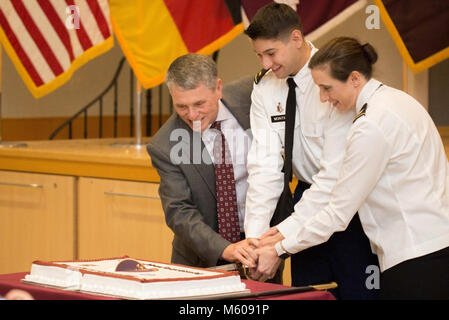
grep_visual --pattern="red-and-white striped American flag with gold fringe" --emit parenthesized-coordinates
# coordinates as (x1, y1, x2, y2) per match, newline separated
(0, 0, 113, 98)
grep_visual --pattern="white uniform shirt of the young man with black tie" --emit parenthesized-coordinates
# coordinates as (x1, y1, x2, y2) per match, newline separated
(245, 42, 354, 238)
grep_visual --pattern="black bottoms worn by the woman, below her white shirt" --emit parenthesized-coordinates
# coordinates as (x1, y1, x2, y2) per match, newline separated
(380, 247, 449, 300)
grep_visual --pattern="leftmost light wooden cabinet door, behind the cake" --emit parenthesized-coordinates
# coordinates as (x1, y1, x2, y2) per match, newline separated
(0, 171, 75, 273)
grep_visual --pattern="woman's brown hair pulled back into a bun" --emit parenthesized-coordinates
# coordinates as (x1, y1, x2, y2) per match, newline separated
(309, 37, 377, 82)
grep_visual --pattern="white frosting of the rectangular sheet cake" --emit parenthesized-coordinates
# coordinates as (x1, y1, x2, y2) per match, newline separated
(25, 259, 245, 299)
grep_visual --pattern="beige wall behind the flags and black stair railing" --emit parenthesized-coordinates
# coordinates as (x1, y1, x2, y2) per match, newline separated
(2, 0, 440, 122)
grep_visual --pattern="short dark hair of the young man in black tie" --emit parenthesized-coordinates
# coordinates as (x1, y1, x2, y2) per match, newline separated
(245, 2, 302, 40)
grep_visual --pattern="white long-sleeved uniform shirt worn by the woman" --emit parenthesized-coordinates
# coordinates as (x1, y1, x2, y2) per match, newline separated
(276, 79, 449, 276)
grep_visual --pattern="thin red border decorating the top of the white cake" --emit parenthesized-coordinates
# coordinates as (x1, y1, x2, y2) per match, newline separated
(33, 255, 240, 283)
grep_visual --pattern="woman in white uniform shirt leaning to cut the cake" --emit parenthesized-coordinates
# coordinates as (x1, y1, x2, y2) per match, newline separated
(254, 37, 449, 299)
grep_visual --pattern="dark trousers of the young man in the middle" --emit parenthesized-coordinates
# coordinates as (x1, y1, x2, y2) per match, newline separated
(291, 181, 379, 300)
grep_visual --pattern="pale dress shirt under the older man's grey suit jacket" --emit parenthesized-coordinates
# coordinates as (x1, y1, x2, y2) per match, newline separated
(201, 101, 251, 232)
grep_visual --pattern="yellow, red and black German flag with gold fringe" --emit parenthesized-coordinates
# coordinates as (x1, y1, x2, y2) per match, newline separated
(109, 0, 243, 88)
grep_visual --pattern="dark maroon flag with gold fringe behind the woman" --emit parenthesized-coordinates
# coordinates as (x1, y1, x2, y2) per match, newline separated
(374, 0, 449, 73)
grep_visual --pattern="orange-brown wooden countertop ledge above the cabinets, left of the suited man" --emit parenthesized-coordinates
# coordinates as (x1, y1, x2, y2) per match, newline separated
(0, 138, 160, 182)
